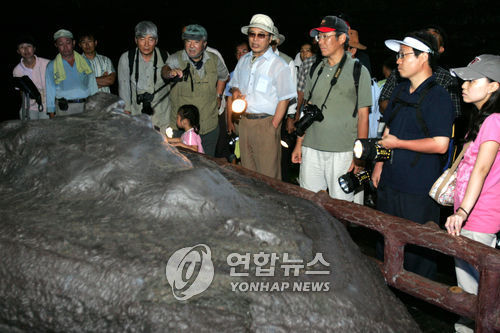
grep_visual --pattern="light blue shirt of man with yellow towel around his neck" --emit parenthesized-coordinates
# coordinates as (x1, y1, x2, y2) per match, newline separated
(45, 58, 97, 112)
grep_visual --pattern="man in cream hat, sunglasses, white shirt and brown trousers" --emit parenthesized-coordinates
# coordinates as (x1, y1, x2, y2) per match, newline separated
(229, 14, 297, 179)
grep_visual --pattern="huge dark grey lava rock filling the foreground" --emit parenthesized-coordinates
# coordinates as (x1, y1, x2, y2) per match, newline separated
(0, 94, 418, 333)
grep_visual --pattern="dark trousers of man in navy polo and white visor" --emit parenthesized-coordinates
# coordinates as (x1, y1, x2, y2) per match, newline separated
(376, 186, 439, 280)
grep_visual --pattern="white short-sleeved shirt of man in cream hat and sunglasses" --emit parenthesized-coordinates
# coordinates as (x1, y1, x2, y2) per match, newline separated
(229, 47, 297, 115)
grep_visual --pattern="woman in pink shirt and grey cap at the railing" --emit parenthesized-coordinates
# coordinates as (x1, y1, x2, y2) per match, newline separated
(446, 54, 500, 332)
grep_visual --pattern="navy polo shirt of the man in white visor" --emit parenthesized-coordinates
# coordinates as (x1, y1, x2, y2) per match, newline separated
(380, 75, 455, 194)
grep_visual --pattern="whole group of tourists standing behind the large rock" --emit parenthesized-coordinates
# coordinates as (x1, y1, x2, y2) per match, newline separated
(10, 14, 500, 331)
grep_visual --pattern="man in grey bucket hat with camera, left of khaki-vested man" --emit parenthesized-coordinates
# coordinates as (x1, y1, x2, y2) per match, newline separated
(118, 21, 170, 133)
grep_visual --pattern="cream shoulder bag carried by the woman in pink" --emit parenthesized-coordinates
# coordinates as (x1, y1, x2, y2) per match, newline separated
(429, 142, 470, 206)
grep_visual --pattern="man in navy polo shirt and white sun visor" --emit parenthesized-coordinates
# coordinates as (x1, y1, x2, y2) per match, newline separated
(372, 30, 455, 279)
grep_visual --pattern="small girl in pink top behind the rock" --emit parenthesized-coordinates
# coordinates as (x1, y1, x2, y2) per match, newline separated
(168, 104, 205, 153)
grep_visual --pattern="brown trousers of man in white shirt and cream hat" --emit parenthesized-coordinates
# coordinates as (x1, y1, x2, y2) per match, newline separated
(239, 116, 281, 179)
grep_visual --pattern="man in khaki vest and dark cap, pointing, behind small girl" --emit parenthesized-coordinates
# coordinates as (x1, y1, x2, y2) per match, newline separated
(161, 24, 229, 156)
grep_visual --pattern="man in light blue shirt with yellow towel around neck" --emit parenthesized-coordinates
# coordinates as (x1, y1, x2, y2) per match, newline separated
(45, 29, 97, 118)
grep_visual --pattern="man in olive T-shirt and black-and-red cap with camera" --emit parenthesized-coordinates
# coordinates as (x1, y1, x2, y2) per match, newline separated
(292, 16, 372, 204)
